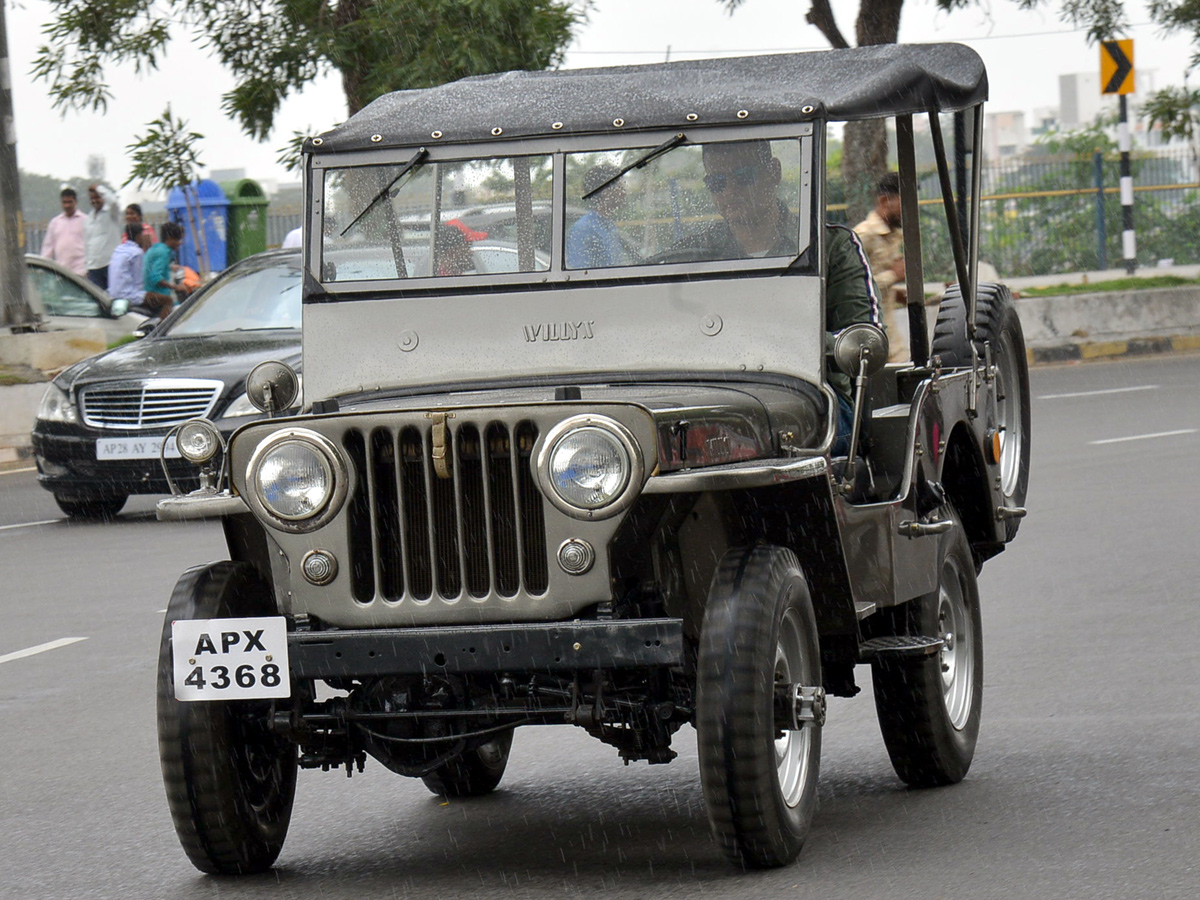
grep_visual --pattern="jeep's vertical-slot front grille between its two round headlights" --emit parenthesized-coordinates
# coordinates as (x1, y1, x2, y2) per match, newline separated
(343, 416, 550, 602)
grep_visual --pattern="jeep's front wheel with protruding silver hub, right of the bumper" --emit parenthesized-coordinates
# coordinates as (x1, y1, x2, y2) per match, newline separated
(696, 546, 821, 869)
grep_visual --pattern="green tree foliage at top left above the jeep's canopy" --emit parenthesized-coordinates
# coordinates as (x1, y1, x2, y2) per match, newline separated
(34, 0, 590, 146)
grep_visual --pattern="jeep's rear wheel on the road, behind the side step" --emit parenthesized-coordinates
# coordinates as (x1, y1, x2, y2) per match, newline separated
(871, 517, 983, 787)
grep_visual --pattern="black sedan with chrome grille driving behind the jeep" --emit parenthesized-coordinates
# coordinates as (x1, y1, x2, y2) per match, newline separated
(32, 251, 300, 517)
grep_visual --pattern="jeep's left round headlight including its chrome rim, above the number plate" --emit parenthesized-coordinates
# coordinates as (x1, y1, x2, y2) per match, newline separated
(246, 428, 349, 532)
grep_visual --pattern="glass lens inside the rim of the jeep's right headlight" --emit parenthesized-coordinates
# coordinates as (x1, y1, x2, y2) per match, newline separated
(548, 426, 630, 510)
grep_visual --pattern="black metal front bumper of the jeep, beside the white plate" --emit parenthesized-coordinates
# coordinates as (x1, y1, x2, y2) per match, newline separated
(288, 619, 683, 678)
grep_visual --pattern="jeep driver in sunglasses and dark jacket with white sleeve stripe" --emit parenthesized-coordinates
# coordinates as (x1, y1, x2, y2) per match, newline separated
(703, 140, 881, 456)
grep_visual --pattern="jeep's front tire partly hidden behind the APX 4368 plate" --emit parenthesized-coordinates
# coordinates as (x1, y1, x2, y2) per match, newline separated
(157, 562, 296, 875)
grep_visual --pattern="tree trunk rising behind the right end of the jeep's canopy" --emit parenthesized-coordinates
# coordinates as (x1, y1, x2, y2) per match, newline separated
(840, 0, 904, 226)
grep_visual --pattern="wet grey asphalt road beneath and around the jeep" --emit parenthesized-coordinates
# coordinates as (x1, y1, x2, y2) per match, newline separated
(0, 356, 1200, 900)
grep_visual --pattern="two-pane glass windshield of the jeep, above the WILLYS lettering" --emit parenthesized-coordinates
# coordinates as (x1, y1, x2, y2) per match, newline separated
(314, 128, 812, 289)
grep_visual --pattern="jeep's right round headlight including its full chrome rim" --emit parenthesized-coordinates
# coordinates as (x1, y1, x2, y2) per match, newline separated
(538, 415, 643, 518)
